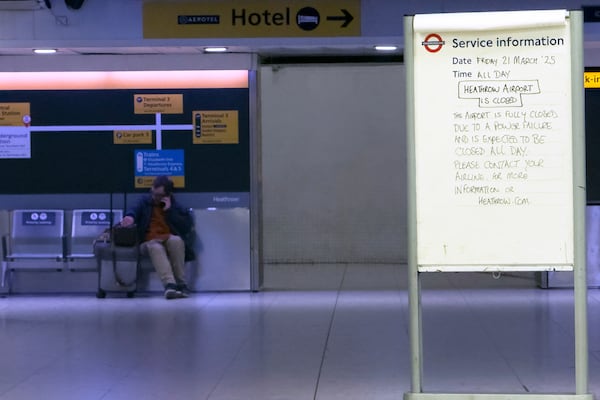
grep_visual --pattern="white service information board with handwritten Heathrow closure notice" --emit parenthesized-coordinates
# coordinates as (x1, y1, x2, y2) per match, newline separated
(409, 10, 574, 271)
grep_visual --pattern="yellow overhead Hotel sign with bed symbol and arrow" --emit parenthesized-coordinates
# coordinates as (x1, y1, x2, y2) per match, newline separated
(143, 0, 361, 39)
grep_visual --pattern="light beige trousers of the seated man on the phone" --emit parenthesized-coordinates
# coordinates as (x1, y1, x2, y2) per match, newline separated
(140, 235, 185, 285)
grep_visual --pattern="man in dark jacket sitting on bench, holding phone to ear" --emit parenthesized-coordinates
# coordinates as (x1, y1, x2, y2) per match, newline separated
(121, 176, 193, 300)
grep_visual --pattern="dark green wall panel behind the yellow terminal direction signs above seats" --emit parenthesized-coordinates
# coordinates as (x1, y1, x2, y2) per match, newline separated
(0, 89, 250, 194)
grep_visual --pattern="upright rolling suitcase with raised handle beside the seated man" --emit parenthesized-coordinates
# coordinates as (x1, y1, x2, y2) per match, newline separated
(94, 194, 140, 299)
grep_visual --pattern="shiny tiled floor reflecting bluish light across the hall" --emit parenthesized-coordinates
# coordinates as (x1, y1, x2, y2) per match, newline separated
(0, 265, 600, 400)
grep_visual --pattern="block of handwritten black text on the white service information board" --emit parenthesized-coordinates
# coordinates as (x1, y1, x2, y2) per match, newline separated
(449, 55, 567, 206)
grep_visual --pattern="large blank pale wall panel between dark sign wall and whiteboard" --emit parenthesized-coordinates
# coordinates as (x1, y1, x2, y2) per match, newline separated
(260, 64, 406, 263)
